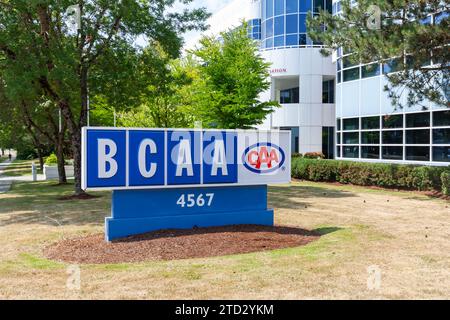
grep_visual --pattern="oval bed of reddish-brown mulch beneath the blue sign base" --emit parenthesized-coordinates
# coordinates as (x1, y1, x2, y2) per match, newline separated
(44, 225, 320, 264)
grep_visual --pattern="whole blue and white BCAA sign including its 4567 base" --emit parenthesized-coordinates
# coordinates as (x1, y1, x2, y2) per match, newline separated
(82, 128, 291, 241)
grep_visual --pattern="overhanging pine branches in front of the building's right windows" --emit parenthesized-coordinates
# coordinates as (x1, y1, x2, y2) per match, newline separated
(307, 0, 450, 107)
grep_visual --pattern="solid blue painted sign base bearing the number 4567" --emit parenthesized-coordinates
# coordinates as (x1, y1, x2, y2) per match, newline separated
(105, 185, 274, 241)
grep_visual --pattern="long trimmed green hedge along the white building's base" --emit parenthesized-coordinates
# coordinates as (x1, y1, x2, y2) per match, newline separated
(292, 158, 450, 194)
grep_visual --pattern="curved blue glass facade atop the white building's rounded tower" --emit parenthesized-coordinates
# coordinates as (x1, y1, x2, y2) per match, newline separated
(260, 0, 332, 49)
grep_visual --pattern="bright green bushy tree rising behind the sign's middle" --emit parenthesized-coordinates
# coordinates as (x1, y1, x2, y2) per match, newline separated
(191, 24, 279, 129)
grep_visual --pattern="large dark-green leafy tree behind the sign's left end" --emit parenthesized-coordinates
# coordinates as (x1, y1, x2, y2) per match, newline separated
(0, 0, 208, 195)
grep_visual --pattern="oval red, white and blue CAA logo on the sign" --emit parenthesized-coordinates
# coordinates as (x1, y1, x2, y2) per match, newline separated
(242, 142, 285, 173)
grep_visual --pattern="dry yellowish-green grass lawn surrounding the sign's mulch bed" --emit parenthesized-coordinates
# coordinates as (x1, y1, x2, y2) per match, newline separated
(0, 182, 450, 299)
